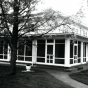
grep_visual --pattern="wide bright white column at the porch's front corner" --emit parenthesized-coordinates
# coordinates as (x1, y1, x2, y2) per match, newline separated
(65, 38, 70, 67)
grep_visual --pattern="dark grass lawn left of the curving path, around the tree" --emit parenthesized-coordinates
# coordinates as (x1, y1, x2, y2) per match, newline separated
(0, 65, 72, 88)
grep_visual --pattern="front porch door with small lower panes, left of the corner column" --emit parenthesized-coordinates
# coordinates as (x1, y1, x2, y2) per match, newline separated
(47, 45, 54, 63)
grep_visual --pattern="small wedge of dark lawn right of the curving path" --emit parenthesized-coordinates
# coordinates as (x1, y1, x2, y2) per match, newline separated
(69, 70, 88, 85)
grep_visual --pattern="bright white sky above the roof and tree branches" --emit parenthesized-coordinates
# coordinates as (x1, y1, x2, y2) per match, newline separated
(37, 0, 88, 24)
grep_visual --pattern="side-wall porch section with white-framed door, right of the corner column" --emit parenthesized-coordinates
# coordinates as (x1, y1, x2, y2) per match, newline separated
(70, 40, 81, 64)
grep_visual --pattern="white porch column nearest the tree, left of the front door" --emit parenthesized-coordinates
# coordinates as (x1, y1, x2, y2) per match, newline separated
(32, 40, 37, 64)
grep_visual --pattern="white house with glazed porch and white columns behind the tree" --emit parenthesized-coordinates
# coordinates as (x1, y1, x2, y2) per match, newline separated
(0, 17, 88, 67)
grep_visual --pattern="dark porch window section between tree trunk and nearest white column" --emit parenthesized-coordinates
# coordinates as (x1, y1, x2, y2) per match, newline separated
(18, 41, 32, 61)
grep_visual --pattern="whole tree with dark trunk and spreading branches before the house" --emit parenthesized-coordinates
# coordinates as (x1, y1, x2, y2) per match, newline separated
(0, 0, 69, 75)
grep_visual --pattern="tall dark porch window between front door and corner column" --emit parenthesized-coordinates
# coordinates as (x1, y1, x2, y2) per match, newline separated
(55, 39, 65, 64)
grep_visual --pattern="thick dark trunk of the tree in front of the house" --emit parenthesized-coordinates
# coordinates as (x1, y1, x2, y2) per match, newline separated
(10, 0, 19, 75)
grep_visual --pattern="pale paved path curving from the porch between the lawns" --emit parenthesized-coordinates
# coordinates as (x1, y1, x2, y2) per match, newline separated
(46, 70, 88, 88)
